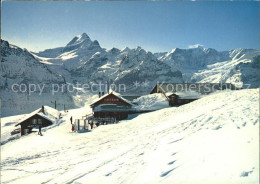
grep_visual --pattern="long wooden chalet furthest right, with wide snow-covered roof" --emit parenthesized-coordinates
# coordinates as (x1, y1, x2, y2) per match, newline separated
(150, 83, 236, 106)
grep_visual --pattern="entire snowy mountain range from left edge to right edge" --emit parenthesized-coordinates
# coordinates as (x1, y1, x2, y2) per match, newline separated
(1, 33, 260, 116)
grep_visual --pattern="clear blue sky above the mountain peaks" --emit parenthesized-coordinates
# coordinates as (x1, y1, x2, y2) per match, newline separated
(1, 1, 259, 52)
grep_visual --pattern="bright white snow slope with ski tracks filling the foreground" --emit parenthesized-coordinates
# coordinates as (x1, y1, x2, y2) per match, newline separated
(1, 89, 259, 184)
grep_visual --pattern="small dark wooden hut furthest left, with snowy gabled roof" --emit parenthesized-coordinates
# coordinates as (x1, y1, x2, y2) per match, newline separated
(15, 106, 58, 135)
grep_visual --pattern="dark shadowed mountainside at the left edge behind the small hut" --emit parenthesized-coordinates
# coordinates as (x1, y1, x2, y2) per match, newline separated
(1, 40, 75, 116)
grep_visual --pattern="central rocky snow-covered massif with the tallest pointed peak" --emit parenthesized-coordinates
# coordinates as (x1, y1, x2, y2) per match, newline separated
(34, 33, 183, 94)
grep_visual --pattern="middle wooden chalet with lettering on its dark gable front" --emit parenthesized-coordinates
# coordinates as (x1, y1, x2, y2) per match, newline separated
(90, 92, 133, 120)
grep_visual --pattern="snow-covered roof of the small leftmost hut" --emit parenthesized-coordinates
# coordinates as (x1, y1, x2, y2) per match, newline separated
(15, 106, 60, 126)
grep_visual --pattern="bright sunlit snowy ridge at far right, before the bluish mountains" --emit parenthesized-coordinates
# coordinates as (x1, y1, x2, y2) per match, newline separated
(191, 49, 260, 88)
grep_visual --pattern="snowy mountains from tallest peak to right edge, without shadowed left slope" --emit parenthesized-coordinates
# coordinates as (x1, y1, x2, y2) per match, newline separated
(35, 33, 260, 89)
